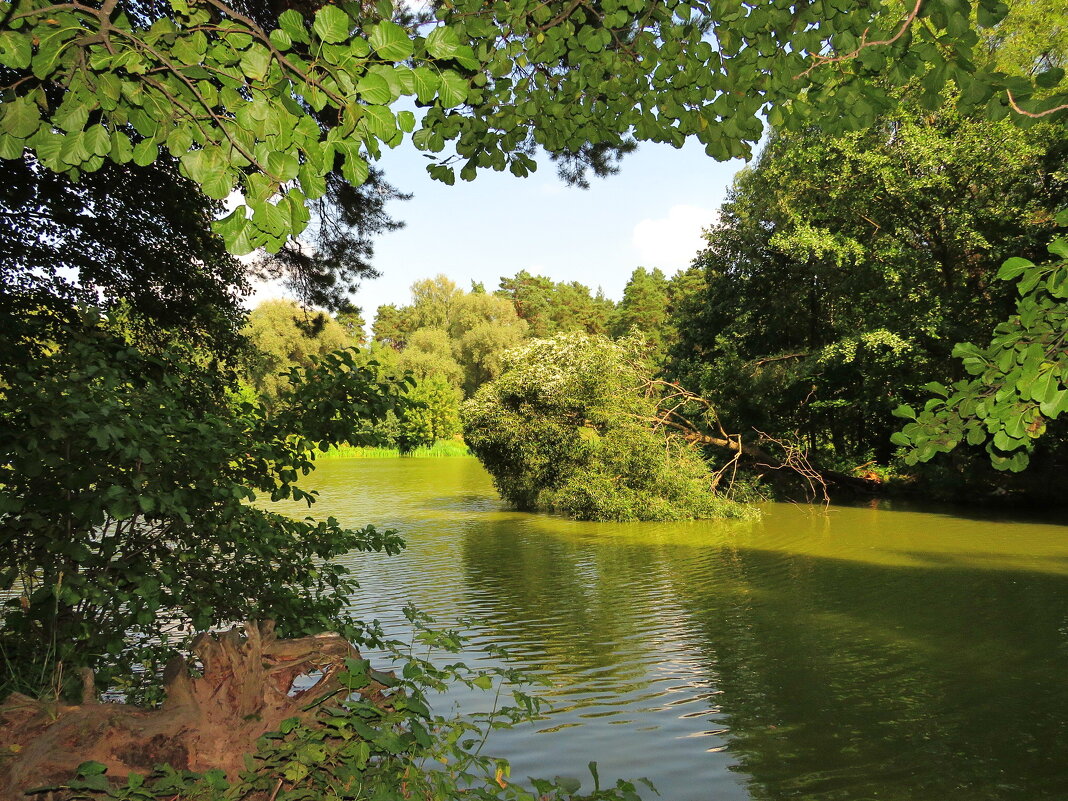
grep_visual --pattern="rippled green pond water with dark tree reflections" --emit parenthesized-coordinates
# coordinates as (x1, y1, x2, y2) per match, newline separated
(299, 458, 1068, 801)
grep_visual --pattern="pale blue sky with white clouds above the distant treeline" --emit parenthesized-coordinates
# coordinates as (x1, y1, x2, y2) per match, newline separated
(253, 135, 743, 324)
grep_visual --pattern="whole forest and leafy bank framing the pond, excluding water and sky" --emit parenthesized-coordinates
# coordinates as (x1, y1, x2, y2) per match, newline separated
(0, 0, 1068, 801)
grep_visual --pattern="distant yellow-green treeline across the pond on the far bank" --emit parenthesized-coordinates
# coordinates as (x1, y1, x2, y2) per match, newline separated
(244, 267, 690, 452)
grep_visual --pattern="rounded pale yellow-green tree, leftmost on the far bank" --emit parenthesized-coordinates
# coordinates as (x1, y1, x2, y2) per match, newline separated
(242, 300, 356, 401)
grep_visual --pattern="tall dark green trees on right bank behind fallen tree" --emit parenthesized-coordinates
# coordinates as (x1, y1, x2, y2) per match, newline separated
(670, 95, 1068, 468)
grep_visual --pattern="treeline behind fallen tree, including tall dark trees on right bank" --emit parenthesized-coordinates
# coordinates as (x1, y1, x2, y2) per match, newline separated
(326, 92, 1068, 497)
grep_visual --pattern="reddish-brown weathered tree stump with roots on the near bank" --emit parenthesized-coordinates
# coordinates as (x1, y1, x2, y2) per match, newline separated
(0, 622, 389, 801)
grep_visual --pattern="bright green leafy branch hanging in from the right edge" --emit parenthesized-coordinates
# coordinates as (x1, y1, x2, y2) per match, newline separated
(893, 226, 1068, 472)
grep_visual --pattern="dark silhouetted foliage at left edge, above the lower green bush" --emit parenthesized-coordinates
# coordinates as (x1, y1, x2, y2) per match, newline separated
(0, 158, 248, 361)
